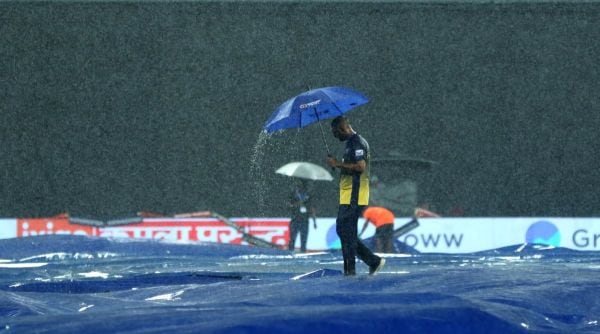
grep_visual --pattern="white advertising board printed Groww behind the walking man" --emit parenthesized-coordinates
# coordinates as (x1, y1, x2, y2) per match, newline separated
(296, 217, 600, 253)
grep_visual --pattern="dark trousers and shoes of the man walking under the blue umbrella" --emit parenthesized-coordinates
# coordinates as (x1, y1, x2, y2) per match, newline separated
(336, 205, 379, 275)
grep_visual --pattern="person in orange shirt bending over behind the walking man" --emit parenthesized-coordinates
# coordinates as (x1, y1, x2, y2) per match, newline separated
(359, 206, 394, 253)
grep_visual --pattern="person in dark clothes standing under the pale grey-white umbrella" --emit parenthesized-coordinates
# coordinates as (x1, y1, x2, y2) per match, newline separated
(288, 180, 317, 253)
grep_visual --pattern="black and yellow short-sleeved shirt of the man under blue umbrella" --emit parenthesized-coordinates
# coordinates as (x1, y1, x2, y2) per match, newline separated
(340, 133, 371, 205)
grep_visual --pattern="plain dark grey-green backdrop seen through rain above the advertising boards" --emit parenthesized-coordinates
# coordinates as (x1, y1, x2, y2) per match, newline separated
(0, 2, 600, 217)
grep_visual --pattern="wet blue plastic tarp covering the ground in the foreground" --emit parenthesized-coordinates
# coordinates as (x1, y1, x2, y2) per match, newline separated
(0, 236, 600, 334)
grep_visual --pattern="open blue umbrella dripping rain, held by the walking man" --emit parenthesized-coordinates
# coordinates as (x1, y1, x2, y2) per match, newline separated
(263, 87, 369, 153)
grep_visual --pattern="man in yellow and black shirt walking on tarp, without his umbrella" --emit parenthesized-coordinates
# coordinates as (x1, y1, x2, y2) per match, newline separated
(327, 116, 385, 276)
